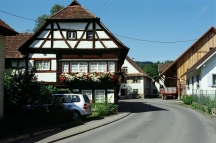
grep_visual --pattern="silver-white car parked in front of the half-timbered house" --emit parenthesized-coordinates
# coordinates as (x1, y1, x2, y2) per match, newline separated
(52, 93, 92, 119)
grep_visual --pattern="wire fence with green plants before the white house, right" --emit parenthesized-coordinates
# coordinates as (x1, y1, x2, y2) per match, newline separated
(192, 89, 216, 108)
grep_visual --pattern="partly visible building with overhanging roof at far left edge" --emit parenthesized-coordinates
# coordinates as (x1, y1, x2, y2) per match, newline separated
(0, 19, 17, 119)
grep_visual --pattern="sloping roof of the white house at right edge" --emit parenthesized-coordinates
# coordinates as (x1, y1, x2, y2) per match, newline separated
(181, 48, 216, 77)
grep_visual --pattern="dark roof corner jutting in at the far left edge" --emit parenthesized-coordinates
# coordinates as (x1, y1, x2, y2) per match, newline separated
(0, 19, 18, 36)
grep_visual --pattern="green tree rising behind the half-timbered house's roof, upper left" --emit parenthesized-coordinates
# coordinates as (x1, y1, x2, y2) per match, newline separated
(33, 4, 64, 32)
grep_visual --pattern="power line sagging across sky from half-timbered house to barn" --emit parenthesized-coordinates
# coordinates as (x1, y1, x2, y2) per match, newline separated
(113, 33, 197, 44)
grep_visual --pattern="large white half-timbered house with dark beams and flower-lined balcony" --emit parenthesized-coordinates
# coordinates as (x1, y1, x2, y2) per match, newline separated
(19, 0, 129, 102)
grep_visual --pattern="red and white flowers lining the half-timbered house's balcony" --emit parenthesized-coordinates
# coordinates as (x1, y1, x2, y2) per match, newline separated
(60, 72, 118, 82)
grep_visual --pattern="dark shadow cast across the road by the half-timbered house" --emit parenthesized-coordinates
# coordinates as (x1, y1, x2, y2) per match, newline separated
(119, 101, 168, 113)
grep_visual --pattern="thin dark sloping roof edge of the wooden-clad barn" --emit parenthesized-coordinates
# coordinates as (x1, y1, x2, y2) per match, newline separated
(157, 26, 216, 80)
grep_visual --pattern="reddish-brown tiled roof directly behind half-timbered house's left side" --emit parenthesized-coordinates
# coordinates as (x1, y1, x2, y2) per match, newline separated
(5, 33, 33, 58)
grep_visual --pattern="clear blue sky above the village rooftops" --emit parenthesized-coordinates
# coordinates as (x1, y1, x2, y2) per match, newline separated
(0, 0, 216, 62)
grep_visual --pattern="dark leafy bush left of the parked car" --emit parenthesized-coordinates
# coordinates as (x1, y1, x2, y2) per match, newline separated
(4, 69, 51, 109)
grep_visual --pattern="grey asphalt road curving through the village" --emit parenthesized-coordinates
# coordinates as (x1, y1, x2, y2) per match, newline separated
(55, 99, 216, 143)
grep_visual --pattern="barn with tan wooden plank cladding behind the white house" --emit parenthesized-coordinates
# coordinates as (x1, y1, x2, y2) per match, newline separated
(157, 27, 216, 99)
